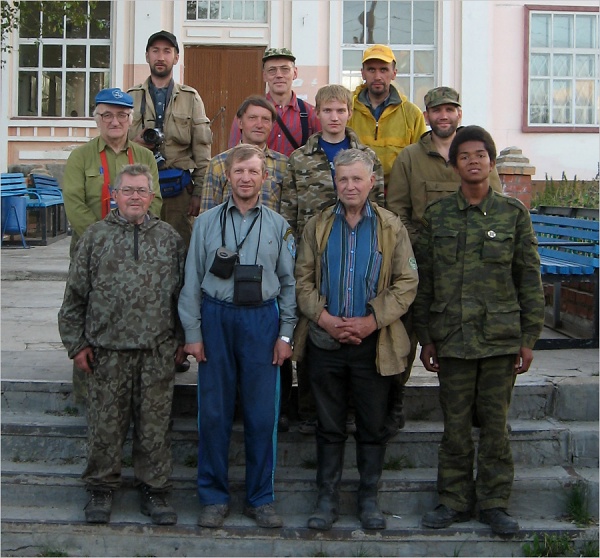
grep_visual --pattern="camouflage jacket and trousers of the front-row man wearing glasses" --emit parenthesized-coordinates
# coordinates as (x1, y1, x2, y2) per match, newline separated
(58, 210, 185, 491)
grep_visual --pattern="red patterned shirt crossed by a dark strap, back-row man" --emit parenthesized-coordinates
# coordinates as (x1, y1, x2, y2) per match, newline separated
(229, 91, 321, 157)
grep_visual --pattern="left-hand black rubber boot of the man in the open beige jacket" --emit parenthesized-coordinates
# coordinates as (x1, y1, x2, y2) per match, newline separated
(308, 443, 344, 531)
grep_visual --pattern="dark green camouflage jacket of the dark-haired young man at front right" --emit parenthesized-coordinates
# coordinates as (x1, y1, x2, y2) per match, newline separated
(413, 189, 544, 359)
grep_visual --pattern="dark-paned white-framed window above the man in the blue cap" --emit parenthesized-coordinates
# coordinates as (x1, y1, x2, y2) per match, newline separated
(18, 1, 111, 117)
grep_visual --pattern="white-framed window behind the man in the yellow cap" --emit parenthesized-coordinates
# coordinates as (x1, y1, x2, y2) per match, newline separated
(342, 0, 437, 106)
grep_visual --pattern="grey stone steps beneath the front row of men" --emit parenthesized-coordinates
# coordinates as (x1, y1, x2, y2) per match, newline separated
(1, 360, 599, 556)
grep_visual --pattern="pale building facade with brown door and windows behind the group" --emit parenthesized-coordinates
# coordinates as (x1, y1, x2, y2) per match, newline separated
(0, 0, 600, 179)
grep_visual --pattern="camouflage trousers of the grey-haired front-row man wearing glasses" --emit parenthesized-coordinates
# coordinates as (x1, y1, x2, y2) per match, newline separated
(82, 340, 176, 492)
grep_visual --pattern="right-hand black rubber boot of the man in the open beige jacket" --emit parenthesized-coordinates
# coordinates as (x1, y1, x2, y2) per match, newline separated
(356, 444, 386, 529)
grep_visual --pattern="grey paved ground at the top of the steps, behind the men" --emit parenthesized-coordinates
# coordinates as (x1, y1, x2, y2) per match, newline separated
(0, 238, 599, 383)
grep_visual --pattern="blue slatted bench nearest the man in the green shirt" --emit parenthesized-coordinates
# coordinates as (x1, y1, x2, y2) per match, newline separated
(27, 174, 67, 246)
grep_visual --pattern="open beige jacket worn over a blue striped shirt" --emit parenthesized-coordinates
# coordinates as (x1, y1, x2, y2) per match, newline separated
(293, 202, 419, 376)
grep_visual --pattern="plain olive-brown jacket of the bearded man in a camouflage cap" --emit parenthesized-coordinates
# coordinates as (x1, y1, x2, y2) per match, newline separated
(385, 128, 502, 245)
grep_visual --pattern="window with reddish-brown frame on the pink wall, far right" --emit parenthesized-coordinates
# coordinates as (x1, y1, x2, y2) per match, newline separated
(525, 7, 600, 131)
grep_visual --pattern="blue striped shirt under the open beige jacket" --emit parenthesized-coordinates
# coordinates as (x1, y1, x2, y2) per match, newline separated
(321, 201, 382, 318)
